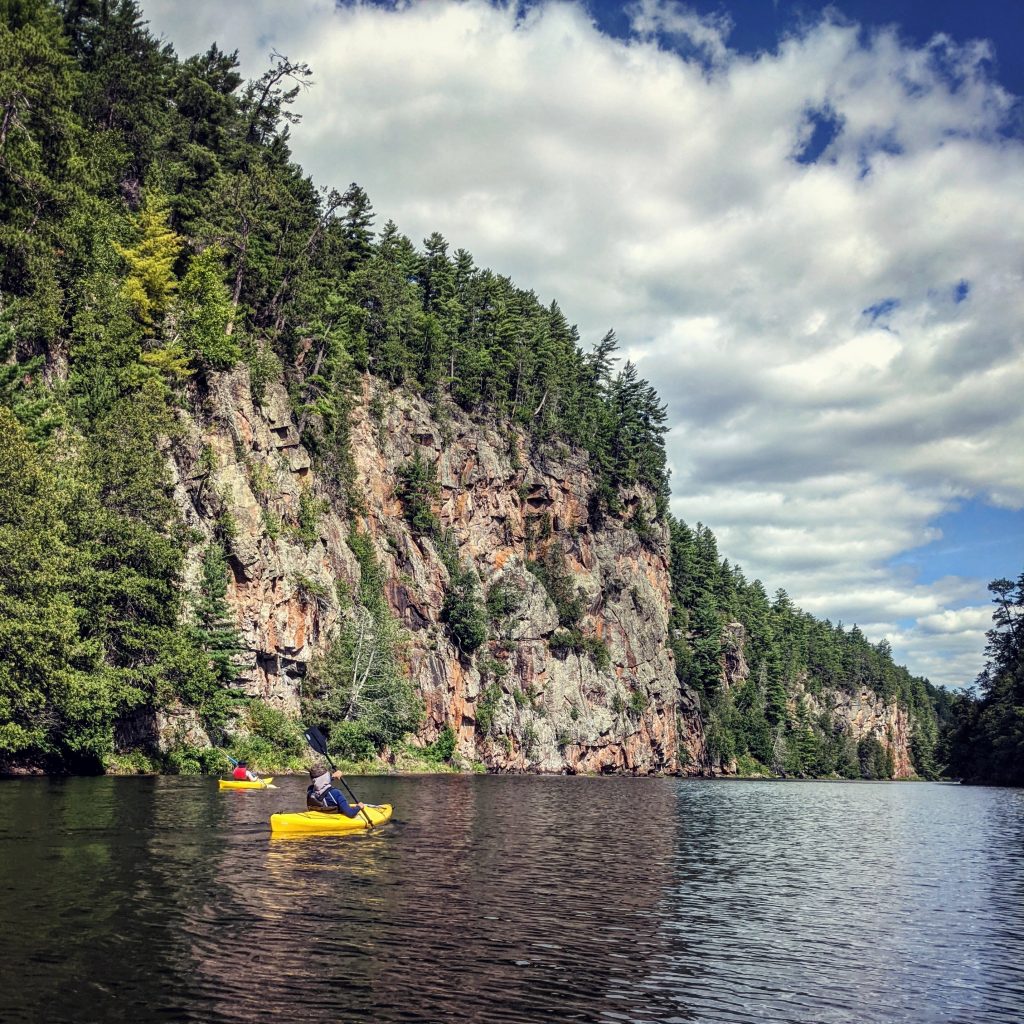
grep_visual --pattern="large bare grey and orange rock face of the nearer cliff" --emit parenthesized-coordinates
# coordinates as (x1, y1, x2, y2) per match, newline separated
(165, 367, 707, 773)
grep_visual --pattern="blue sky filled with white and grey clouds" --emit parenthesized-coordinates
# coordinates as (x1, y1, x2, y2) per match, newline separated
(142, 0, 1024, 686)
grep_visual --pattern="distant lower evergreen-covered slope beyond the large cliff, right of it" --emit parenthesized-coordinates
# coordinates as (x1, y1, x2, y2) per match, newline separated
(672, 521, 939, 778)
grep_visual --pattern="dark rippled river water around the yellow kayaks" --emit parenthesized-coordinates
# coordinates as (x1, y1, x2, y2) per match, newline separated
(0, 776, 1024, 1024)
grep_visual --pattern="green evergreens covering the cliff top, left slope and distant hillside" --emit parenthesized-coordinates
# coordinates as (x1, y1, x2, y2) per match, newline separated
(0, 0, 987, 777)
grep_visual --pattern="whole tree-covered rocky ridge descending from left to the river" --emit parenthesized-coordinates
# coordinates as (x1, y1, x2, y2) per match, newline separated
(0, 0, 937, 777)
